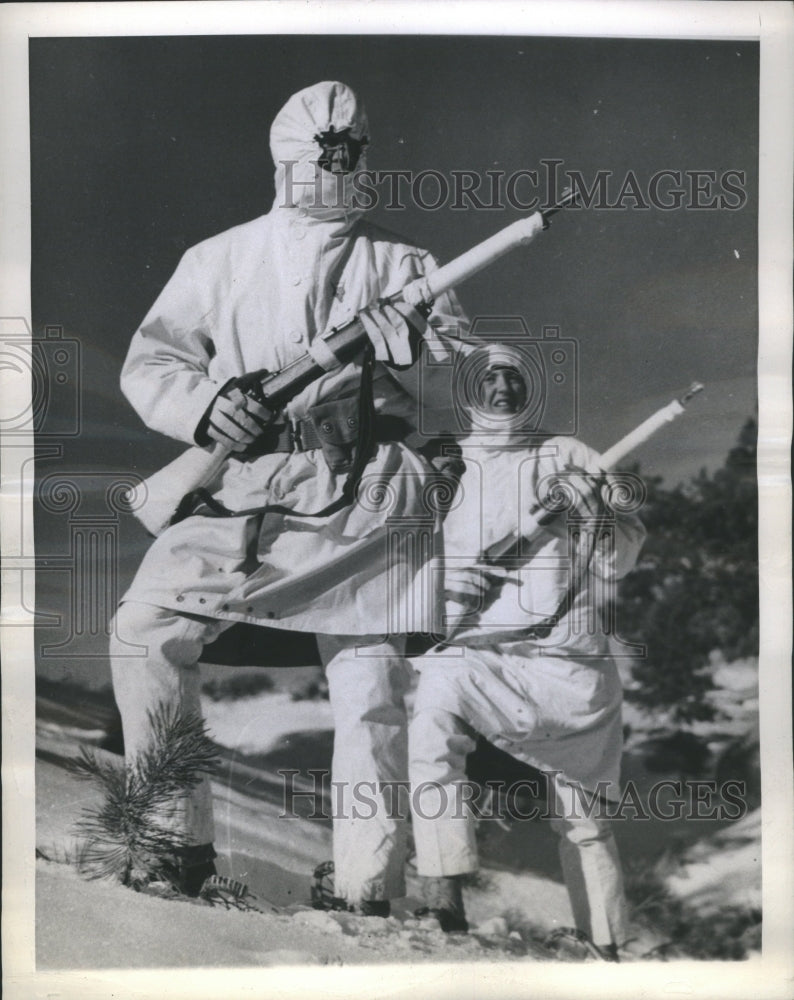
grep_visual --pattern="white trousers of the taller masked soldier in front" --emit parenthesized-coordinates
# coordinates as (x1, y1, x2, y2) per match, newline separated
(110, 601, 409, 903)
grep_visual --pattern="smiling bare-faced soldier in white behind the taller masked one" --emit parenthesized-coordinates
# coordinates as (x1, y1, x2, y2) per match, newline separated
(409, 345, 645, 958)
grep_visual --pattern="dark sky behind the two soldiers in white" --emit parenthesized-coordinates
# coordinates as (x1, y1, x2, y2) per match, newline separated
(30, 35, 758, 616)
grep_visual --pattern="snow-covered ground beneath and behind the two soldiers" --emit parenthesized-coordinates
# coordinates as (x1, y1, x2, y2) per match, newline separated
(36, 663, 760, 969)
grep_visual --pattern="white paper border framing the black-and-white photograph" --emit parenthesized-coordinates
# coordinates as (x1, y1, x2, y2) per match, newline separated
(0, 0, 794, 1000)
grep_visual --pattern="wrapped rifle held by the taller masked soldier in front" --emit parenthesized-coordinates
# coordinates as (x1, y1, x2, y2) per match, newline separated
(129, 190, 576, 535)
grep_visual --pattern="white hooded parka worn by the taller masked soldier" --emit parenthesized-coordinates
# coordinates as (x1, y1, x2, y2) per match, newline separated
(121, 83, 465, 635)
